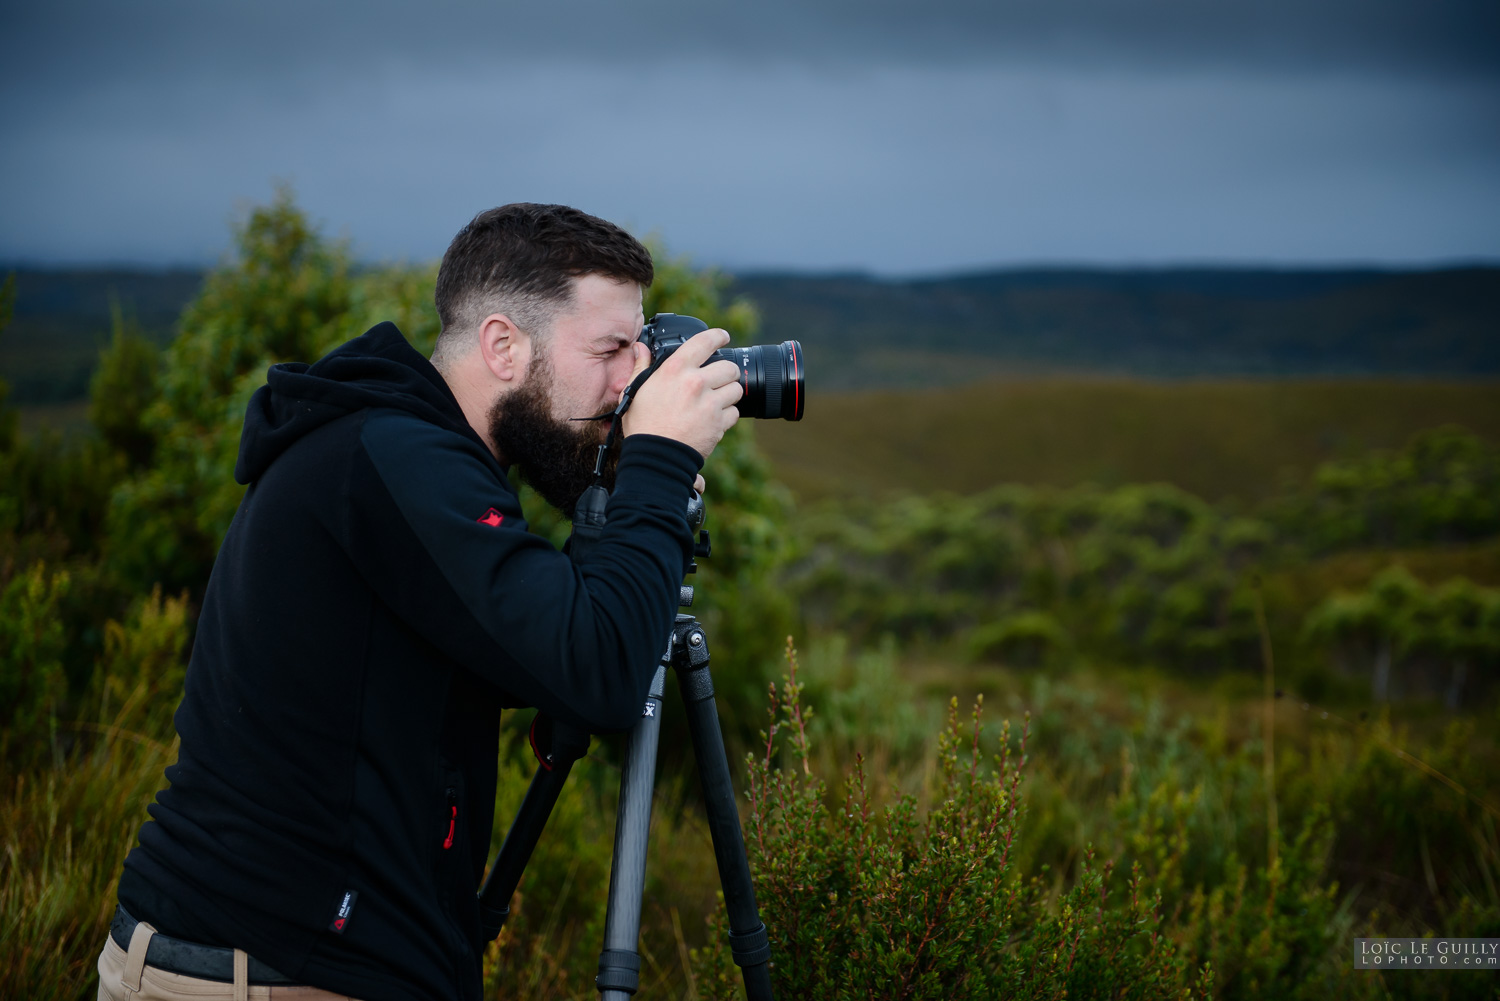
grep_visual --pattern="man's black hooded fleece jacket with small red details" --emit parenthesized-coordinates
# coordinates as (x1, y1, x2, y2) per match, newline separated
(120, 323, 702, 1001)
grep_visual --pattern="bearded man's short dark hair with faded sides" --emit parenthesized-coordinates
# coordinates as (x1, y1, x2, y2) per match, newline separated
(432, 201, 656, 360)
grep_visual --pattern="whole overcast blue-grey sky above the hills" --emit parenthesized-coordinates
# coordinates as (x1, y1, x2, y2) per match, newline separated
(0, 0, 1500, 275)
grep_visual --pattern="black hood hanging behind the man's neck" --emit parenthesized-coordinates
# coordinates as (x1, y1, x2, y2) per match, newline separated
(234, 323, 489, 485)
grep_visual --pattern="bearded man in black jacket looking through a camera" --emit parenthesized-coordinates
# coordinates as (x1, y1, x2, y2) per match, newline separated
(99, 204, 741, 1001)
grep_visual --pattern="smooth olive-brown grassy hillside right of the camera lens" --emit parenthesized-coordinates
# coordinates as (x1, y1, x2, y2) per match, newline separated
(756, 374, 1500, 504)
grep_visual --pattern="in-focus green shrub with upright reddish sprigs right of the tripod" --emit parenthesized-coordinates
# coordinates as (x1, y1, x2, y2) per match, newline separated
(698, 644, 1212, 998)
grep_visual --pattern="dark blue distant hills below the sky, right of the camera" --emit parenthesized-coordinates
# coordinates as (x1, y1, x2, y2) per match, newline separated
(732, 267, 1500, 389)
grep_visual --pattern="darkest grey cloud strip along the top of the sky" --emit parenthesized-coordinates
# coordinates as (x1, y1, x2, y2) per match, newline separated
(0, 0, 1500, 87)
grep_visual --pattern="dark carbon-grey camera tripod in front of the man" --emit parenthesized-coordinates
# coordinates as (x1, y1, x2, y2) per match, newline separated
(479, 486, 771, 1001)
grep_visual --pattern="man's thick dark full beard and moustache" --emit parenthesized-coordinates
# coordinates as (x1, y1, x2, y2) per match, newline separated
(489, 354, 620, 521)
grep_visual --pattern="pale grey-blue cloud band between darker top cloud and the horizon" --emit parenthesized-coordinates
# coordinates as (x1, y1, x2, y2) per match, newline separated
(0, 60, 1500, 273)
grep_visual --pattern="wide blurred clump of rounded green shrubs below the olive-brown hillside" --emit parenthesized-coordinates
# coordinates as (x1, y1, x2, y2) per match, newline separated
(788, 485, 1274, 669)
